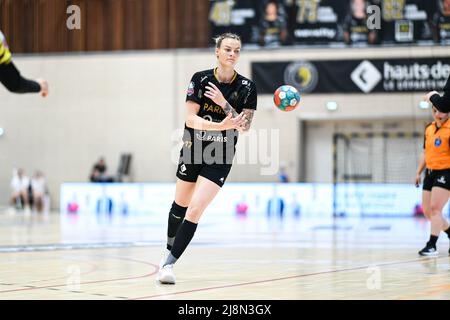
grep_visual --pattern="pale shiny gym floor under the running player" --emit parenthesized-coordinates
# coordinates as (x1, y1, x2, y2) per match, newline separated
(0, 211, 450, 300)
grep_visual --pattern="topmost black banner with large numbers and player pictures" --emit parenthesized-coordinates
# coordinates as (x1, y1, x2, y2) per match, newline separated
(209, 0, 442, 45)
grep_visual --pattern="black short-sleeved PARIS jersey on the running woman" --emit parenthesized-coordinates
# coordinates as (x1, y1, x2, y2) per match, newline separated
(183, 69, 257, 164)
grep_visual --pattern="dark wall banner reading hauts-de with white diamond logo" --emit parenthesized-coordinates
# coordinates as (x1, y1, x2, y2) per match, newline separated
(252, 57, 450, 94)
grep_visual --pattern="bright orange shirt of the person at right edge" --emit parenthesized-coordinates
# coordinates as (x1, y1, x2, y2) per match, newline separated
(424, 120, 450, 170)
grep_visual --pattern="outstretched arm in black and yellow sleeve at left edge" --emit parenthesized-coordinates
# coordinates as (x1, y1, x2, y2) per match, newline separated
(0, 31, 48, 97)
